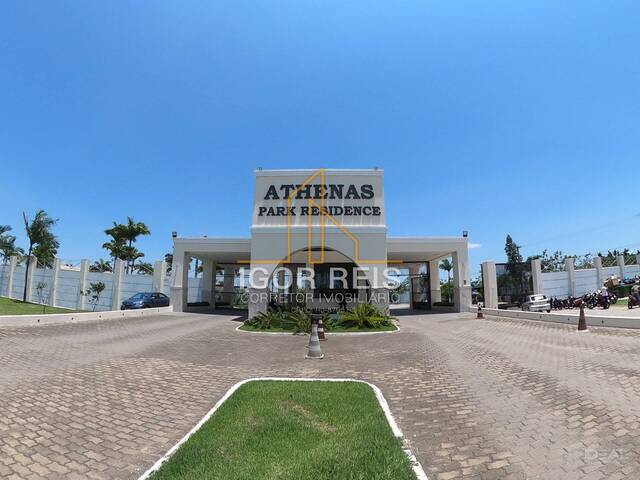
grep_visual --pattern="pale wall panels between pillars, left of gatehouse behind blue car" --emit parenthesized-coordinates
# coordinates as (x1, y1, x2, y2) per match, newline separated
(0, 265, 202, 311)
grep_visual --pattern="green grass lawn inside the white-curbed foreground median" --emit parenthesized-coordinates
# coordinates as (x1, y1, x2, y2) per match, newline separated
(151, 380, 416, 480)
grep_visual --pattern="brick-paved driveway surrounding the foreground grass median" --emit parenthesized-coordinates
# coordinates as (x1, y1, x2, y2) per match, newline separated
(0, 314, 640, 480)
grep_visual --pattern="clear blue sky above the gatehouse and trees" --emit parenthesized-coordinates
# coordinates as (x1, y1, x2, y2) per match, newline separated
(0, 0, 640, 272)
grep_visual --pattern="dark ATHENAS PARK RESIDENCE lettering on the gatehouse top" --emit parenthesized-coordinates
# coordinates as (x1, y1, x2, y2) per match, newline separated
(258, 183, 381, 217)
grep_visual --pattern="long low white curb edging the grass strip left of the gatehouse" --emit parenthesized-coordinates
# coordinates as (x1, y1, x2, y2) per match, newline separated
(0, 307, 172, 328)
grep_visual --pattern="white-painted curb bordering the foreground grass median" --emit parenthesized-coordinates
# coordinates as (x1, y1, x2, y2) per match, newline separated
(138, 377, 429, 480)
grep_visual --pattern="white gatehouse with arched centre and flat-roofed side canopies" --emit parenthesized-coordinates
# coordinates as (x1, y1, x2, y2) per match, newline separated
(171, 169, 471, 317)
